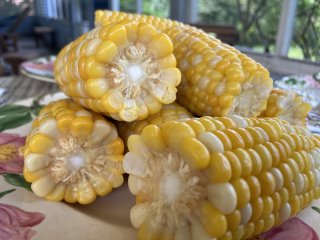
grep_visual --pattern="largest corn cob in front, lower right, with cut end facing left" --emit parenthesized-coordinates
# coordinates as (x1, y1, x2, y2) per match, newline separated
(123, 116, 320, 240)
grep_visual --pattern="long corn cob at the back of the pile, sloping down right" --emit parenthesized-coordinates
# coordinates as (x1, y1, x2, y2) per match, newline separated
(95, 11, 272, 117)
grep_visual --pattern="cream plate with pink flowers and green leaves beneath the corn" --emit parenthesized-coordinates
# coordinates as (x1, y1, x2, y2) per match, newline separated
(0, 93, 320, 240)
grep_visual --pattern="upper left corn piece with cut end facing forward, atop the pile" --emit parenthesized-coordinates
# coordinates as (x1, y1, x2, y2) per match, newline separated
(55, 21, 181, 121)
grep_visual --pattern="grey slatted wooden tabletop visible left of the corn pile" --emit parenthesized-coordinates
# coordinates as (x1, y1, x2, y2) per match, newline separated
(0, 75, 59, 105)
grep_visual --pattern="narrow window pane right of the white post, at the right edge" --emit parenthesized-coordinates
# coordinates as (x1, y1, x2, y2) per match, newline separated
(288, 0, 320, 62)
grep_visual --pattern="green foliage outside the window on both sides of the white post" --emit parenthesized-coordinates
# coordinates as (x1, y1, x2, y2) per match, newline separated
(198, 0, 320, 61)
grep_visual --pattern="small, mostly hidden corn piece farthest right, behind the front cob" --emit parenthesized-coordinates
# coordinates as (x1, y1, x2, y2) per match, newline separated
(260, 88, 311, 126)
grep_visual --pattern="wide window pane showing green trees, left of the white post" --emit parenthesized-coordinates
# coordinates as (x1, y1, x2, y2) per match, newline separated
(198, 0, 282, 53)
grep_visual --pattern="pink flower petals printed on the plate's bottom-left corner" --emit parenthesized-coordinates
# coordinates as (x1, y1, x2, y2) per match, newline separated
(0, 203, 45, 240)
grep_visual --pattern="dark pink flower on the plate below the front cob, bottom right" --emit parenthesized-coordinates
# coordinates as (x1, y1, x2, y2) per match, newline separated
(254, 217, 319, 240)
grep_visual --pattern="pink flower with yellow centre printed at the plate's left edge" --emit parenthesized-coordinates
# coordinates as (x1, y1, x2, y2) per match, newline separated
(0, 132, 26, 173)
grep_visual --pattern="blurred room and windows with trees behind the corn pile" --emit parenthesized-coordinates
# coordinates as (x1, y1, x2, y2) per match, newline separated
(0, 0, 320, 77)
